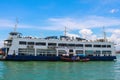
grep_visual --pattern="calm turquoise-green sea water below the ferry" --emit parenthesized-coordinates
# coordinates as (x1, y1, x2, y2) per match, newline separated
(0, 54, 120, 80)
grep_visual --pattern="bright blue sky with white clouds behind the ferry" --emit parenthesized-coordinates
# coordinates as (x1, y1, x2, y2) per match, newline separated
(0, 0, 120, 50)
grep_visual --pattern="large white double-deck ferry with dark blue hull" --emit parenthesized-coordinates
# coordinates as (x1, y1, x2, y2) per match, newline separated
(1, 26, 116, 61)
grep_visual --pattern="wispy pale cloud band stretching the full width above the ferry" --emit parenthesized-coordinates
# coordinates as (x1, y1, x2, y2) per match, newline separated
(0, 16, 120, 31)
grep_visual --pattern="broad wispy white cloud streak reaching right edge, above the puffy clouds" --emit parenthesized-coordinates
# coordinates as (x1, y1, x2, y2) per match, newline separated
(48, 16, 120, 30)
